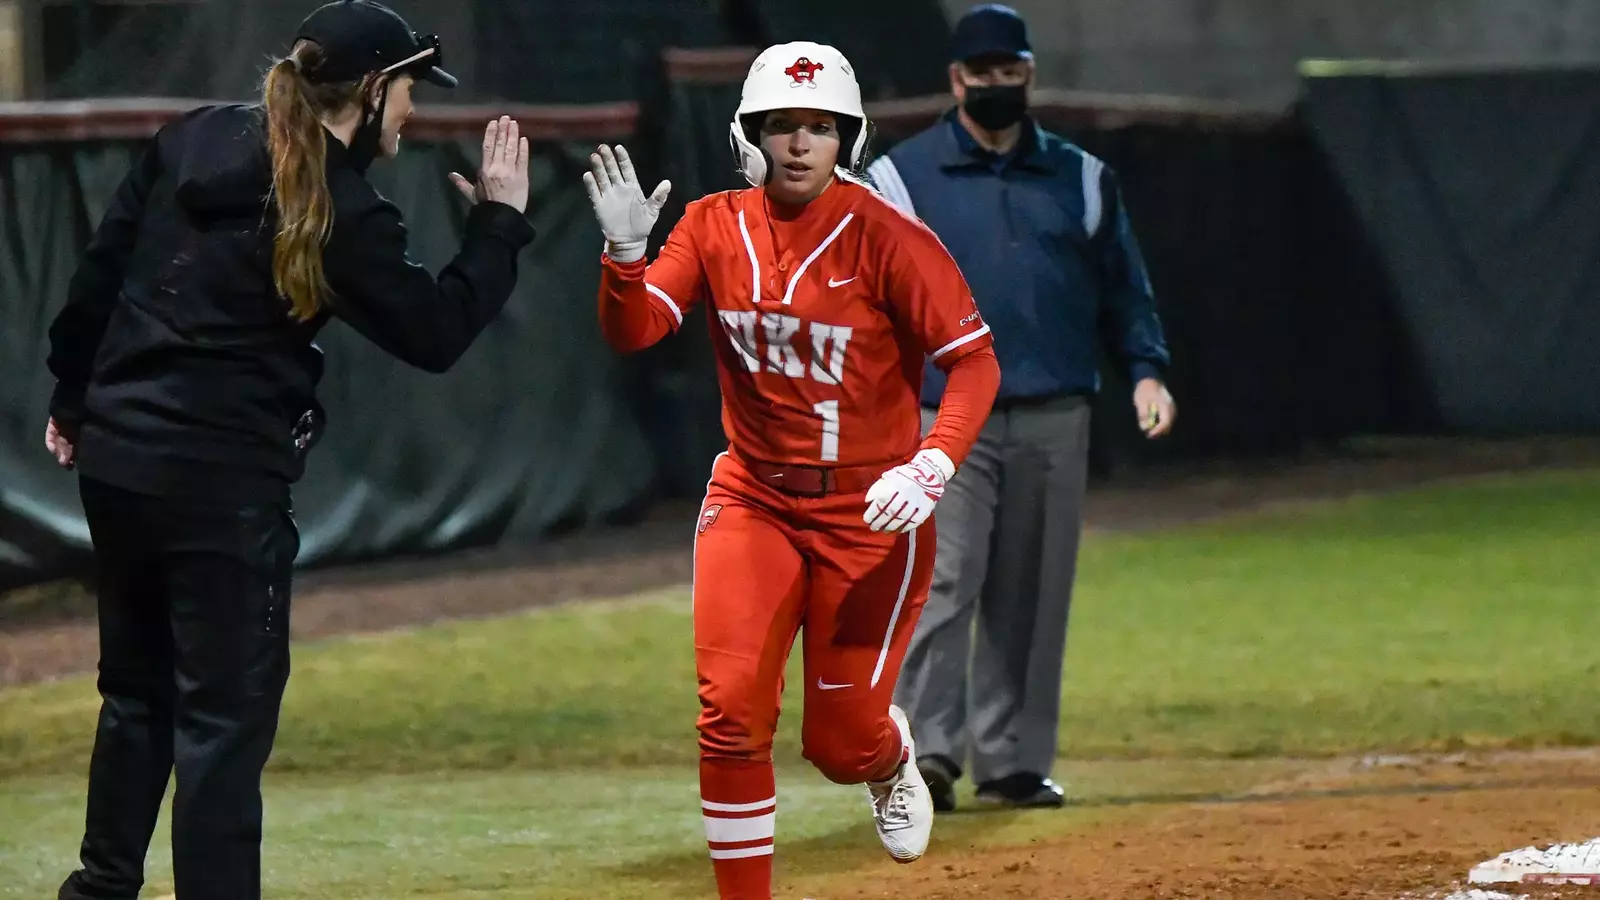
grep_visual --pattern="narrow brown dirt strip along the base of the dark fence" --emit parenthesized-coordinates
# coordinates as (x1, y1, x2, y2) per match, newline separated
(0, 439, 1600, 687)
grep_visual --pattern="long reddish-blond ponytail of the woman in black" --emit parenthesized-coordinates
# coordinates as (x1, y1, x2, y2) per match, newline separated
(261, 40, 362, 322)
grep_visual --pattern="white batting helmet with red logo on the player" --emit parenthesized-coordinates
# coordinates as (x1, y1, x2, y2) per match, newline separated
(728, 40, 867, 187)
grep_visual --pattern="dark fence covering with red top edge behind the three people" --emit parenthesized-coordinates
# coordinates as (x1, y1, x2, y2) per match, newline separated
(0, 31, 1600, 588)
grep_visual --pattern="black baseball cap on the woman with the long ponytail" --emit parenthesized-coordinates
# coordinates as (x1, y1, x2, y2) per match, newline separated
(294, 0, 459, 88)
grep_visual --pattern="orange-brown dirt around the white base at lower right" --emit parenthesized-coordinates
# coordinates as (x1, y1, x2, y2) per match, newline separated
(832, 751, 1600, 900)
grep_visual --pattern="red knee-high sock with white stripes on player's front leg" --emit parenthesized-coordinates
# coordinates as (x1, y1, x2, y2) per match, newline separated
(701, 756, 778, 900)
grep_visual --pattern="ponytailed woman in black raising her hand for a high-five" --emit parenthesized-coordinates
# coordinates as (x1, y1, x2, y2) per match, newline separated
(37, 0, 533, 900)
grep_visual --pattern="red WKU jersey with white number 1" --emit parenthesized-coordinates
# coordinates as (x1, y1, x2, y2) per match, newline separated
(600, 179, 998, 466)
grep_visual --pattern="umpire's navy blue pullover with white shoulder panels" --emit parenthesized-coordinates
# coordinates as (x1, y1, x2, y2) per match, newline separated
(867, 109, 1170, 407)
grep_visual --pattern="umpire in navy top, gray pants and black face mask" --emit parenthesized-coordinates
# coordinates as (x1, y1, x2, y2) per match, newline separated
(867, 5, 1174, 810)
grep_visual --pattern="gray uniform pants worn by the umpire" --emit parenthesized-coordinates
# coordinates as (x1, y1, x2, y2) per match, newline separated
(894, 397, 1090, 783)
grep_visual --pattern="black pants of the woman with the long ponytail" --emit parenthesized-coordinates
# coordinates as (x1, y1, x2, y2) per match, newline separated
(61, 477, 299, 900)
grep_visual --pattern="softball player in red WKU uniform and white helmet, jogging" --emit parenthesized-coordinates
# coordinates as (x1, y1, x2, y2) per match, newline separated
(584, 42, 1000, 900)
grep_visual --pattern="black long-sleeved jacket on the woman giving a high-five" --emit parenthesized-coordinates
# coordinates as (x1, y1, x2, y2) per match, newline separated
(48, 106, 533, 500)
